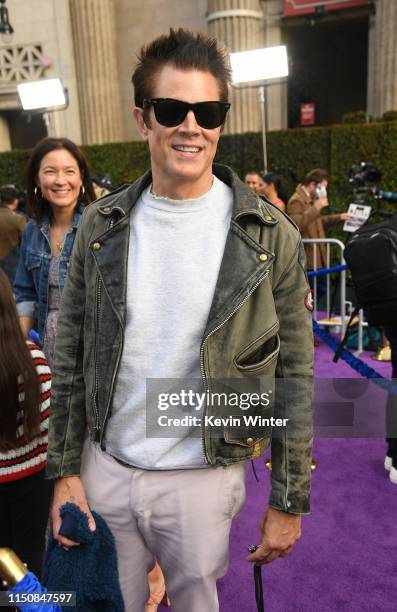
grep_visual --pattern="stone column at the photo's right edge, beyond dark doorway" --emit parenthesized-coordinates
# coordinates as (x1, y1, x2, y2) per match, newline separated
(367, 0, 397, 116)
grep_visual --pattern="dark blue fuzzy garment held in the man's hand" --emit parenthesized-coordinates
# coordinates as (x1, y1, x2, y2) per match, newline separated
(43, 503, 123, 612)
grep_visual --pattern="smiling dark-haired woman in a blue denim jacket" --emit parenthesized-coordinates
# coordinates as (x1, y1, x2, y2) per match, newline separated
(14, 138, 95, 364)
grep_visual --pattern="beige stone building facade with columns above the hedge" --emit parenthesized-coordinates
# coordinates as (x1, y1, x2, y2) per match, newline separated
(0, 0, 397, 151)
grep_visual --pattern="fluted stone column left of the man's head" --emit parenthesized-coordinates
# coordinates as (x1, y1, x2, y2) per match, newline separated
(70, 0, 122, 144)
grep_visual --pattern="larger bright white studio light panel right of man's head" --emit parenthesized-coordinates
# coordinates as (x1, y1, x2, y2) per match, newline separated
(230, 45, 288, 85)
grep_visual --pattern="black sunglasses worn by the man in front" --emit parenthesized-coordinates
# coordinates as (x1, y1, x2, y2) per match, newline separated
(143, 98, 230, 130)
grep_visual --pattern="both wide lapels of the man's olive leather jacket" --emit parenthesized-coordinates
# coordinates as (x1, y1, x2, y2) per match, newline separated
(90, 164, 277, 335)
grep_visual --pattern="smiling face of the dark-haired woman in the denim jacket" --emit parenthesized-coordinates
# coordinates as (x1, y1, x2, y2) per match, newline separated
(37, 149, 83, 210)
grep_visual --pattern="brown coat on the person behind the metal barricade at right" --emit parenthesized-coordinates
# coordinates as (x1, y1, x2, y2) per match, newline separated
(286, 185, 340, 270)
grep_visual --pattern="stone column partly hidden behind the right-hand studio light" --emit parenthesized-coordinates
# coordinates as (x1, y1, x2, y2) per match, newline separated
(207, 0, 264, 134)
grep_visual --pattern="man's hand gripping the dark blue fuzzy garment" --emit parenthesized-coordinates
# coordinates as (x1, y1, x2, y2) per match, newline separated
(51, 476, 96, 547)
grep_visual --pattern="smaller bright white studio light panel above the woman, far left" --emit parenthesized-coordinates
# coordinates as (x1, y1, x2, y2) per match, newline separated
(18, 79, 66, 110)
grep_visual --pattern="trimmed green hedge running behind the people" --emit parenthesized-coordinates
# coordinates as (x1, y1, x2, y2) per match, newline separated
(0, 122, 397, 219)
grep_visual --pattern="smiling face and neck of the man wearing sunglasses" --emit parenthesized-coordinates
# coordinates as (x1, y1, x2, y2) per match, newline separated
(134, 65, 221, 199)
